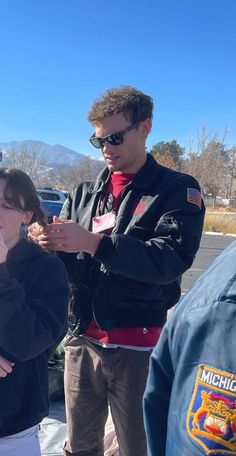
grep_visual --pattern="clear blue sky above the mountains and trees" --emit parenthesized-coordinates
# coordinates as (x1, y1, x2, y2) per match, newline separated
(0, 0, 236, 156)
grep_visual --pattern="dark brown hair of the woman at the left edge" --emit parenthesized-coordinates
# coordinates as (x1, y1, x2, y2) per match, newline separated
(0, 168, 46, 225)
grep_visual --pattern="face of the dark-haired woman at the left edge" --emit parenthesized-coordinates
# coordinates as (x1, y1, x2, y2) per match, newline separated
(0, 178, 32, 249)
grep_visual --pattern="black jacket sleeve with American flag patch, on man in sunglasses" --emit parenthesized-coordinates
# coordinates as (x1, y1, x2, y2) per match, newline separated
(95, 176, 205, 285)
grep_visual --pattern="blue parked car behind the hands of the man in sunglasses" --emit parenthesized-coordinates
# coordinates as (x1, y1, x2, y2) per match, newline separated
(36, 187, 66, 223)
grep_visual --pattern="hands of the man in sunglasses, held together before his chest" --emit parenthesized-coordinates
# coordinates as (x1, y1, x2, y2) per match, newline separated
(29, 217, 101, 255)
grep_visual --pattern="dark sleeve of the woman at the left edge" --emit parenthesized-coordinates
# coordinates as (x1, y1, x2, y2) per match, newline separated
(0, 255, 68, 361)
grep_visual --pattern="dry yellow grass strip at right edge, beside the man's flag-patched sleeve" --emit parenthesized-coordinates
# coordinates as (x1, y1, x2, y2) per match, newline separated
(203, 212, 236, 234)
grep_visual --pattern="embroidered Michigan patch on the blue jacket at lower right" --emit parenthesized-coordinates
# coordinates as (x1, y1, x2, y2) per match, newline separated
(186, 365, 236, 455)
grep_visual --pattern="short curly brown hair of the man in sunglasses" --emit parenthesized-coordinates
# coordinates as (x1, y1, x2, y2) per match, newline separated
(88, 86, 153, 125)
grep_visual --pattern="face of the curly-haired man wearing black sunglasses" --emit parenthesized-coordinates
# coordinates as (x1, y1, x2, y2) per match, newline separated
(94, 114, 151, 174)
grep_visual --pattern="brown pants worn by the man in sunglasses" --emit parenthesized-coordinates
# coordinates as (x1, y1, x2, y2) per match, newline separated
(64, 336, 151, 456)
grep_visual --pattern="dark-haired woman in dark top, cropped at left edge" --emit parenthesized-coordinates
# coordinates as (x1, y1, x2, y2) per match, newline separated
(0, 168, 68, 456)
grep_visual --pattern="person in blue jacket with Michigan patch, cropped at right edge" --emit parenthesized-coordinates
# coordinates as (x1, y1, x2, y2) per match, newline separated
(143, 241, 236, 456)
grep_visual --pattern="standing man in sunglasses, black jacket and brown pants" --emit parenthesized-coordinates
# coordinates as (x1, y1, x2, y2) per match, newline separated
(31, 86, 204, 456)
